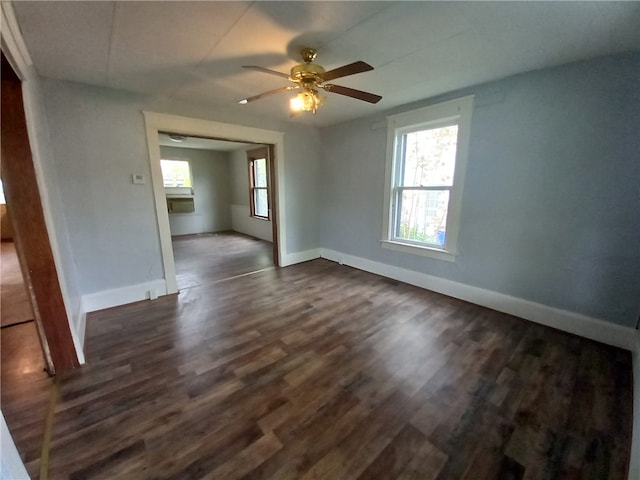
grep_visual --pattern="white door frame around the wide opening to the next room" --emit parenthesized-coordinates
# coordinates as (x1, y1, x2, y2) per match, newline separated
(142, 111, 287, 294)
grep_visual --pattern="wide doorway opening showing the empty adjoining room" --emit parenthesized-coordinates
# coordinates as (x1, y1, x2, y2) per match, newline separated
(158, 132, 277, 290)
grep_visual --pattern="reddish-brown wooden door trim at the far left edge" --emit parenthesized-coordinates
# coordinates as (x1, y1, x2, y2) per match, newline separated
(0, 53, 79, 374)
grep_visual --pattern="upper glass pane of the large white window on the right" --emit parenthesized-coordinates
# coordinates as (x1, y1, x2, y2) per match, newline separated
(402, 125, 458, 187)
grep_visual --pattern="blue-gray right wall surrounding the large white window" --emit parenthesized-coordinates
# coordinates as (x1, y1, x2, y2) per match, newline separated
(319, 55, 640, 326)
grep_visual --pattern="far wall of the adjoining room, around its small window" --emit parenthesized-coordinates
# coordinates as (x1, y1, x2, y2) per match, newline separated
(160, 146, 231, 235)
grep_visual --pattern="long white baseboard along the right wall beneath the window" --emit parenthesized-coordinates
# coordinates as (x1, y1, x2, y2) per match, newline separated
(321, 249, 636, 351)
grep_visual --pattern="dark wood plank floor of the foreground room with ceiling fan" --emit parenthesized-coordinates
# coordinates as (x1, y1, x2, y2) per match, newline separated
(3, 232, 632, 480)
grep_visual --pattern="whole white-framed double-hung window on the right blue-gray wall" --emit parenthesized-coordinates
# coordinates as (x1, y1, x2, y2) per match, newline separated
(383, 96, 473, 261)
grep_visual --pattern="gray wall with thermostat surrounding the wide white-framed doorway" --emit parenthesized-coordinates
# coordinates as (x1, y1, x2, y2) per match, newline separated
(42, 79, 320, 295)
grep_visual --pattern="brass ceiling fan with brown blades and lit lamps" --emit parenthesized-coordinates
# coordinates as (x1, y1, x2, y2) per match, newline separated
(238, 48, 382, 115)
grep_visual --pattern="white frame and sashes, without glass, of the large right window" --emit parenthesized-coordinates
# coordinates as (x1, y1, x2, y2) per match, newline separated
(381, 95, 473, 262)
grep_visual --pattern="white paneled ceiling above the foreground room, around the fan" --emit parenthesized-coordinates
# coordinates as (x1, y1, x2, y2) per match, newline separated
(14, 1, 640, 126)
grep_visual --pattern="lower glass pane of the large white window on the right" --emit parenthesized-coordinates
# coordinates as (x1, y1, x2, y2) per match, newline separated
(396, 190, 449, 247)
